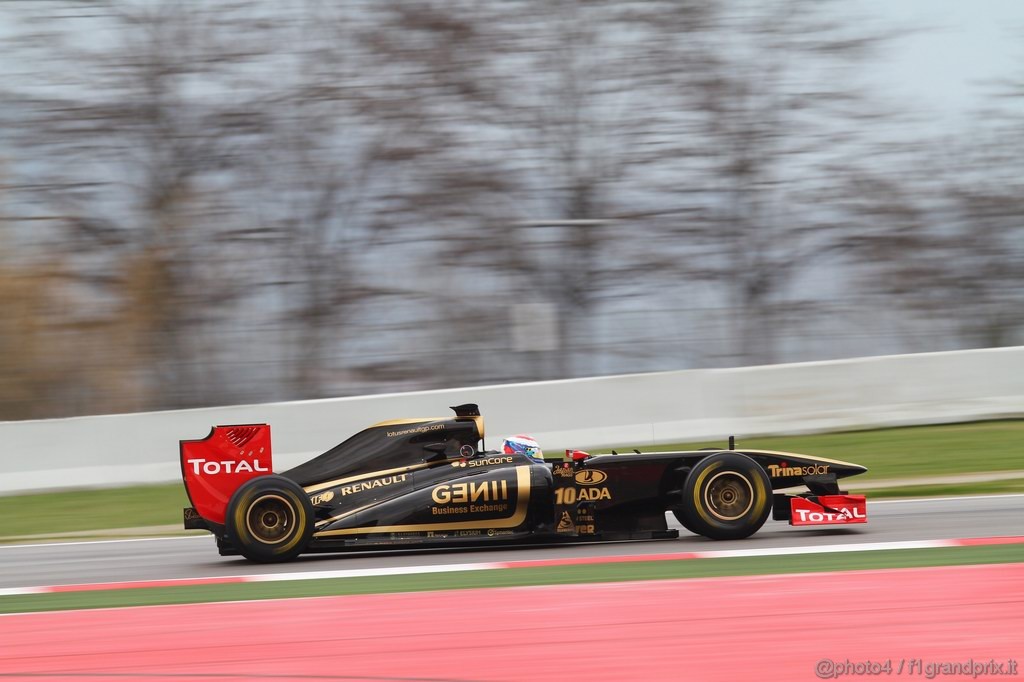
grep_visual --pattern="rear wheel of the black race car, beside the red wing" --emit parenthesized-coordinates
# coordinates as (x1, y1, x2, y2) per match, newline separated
(225, 475, 313, 563)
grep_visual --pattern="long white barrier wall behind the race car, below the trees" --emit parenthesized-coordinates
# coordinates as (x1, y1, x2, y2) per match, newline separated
(0, 346, 1024, 495)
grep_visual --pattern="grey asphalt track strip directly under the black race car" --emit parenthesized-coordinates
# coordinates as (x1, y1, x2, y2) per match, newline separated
(0, 495, 1024, 589)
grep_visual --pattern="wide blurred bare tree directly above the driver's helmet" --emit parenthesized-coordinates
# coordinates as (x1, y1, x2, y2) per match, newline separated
(364, 0, 709, 378)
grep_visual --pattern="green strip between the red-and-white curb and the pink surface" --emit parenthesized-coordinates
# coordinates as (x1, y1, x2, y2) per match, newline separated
(0, 545, 1024, 613)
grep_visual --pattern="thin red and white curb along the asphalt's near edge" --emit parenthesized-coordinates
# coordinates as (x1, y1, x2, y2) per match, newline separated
(0, 536, 1024, 597)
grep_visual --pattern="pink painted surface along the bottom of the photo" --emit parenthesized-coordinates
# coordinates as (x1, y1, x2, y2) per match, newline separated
(0, 564, 1024, 682)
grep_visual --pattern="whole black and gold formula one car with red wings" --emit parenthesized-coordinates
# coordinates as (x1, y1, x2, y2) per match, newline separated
(180, 404, 867, 561)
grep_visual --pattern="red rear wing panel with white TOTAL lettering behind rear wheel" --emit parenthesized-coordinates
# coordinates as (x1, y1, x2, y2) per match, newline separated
(180, 424, 273, 524)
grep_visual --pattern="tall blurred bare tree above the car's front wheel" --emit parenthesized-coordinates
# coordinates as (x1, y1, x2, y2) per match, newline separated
(649, 0, 887, 365)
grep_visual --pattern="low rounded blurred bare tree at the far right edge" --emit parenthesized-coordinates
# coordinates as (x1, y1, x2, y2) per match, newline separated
(846, 122, 1024, 347)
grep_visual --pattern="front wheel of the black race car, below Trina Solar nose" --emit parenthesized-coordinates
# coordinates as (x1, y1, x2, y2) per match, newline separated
(672, 453, 771, 540)
